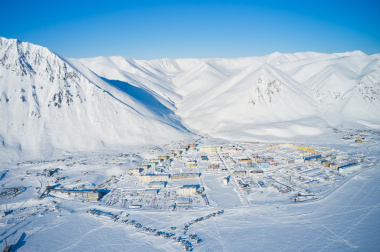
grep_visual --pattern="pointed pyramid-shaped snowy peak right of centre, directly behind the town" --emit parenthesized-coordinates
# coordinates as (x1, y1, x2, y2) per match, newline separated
(174, 64, 325, 140)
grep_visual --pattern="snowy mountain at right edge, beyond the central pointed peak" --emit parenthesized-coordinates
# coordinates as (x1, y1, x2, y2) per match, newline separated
(278, 51, 380, 126)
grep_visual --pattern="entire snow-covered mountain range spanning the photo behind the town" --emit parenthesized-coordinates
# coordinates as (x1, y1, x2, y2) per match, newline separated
(0, 38, 380, 157)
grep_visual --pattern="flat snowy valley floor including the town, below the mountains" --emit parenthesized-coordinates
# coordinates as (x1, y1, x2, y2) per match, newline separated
(0, 132, 380, 251)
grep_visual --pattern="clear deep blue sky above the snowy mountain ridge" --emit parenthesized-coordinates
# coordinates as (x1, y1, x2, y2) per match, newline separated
(0, 0, 380, 59)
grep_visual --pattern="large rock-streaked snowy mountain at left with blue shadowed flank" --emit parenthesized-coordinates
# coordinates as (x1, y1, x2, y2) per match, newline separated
(0, 38, 188, 158)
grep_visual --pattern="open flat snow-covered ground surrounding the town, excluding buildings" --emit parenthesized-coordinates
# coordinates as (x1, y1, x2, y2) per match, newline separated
(0, 133, 380, 251)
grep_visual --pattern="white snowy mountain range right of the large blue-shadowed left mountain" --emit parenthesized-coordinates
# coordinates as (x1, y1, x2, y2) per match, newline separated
(80, 51, 380, 140)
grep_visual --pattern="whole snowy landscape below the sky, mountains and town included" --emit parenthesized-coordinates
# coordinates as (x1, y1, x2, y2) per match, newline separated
(0, 37, 380, 251)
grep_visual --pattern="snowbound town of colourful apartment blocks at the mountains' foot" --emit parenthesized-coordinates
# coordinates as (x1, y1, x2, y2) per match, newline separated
(0, 133, 378, 250)
